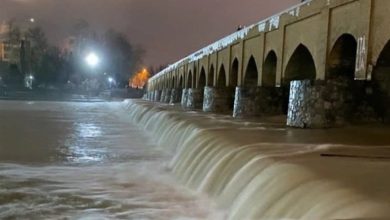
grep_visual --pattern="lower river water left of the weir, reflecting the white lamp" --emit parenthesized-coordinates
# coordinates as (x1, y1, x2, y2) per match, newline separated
(0, 101, 219, 219)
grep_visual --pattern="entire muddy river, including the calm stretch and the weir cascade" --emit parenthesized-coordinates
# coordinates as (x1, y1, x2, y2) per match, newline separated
(0, 101, 390, 220)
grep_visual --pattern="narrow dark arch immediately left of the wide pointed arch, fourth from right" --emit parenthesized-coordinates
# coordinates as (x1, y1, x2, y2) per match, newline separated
(262, 50, 278, 87)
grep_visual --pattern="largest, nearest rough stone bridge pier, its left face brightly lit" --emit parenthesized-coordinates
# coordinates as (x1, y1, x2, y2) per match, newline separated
(287, 80, 352, 128)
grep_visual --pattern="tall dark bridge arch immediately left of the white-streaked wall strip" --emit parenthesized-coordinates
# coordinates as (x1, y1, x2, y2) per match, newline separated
(326, 34, 357, 80)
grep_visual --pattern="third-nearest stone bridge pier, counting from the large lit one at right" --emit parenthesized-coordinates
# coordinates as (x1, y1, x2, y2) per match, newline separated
(203, 86, 233, 113)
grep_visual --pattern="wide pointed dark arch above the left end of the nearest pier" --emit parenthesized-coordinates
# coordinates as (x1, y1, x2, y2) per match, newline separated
(284, 44, 316, 83)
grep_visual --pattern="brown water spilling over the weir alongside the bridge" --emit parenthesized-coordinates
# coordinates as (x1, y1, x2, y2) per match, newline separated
(125, 100, 390, 220)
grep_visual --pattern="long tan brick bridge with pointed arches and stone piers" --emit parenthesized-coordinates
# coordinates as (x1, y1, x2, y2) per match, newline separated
(146, 0, 390, 127)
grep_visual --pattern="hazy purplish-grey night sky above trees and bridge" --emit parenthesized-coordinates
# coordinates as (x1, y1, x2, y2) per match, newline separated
(0, 0, 300, 65)
